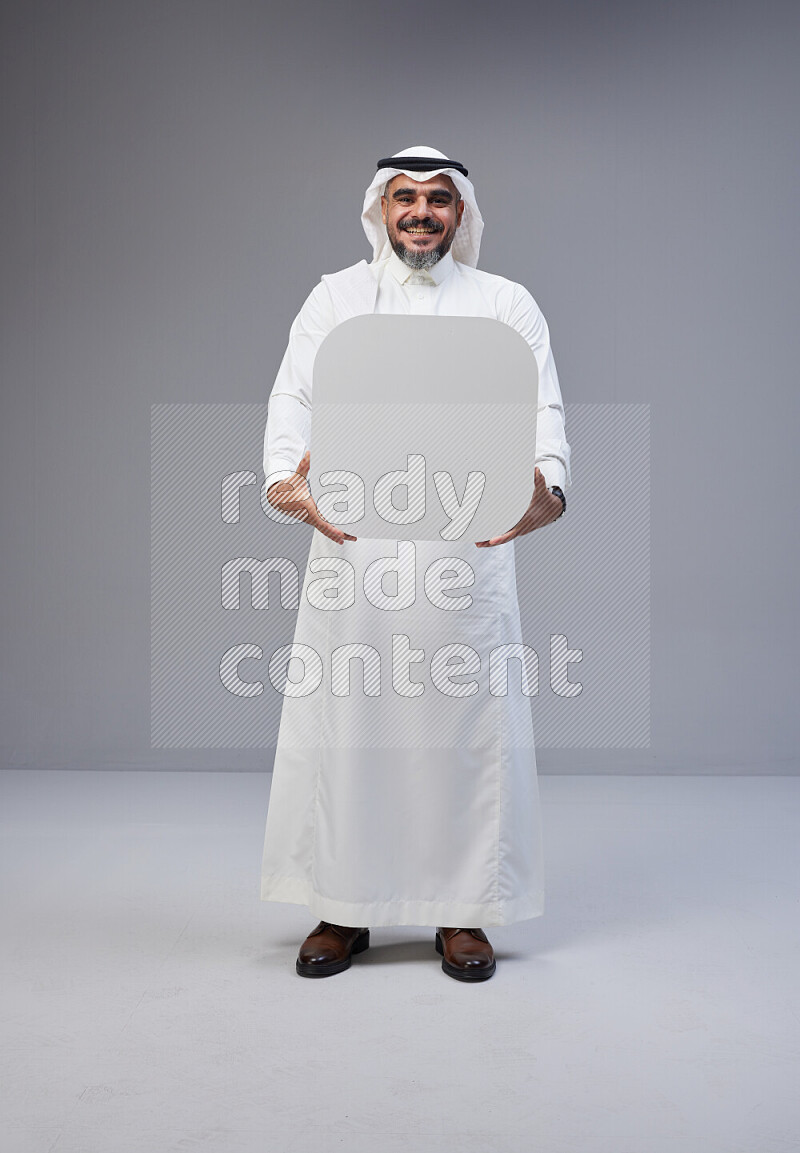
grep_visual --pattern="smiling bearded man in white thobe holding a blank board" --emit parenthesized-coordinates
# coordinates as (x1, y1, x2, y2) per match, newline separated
(262, 146, 569, 981)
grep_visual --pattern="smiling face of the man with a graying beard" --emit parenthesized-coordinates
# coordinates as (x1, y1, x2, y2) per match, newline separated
(380, 173, 463, 269)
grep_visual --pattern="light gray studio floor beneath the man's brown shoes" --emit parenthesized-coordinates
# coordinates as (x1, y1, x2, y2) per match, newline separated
(0, 771, 800, 1153)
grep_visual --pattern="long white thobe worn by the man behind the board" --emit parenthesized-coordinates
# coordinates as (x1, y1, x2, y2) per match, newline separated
(261, 254, 569, 926)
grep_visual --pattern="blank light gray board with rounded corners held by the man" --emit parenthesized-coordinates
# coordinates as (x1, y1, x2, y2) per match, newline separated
(309, 315, 538, 543)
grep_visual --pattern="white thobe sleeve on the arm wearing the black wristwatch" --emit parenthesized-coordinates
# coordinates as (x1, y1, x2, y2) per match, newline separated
(503, 285, 572, 489)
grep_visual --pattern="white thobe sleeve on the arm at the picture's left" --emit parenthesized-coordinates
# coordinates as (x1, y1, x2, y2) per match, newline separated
(264, 282, 333, 488)
